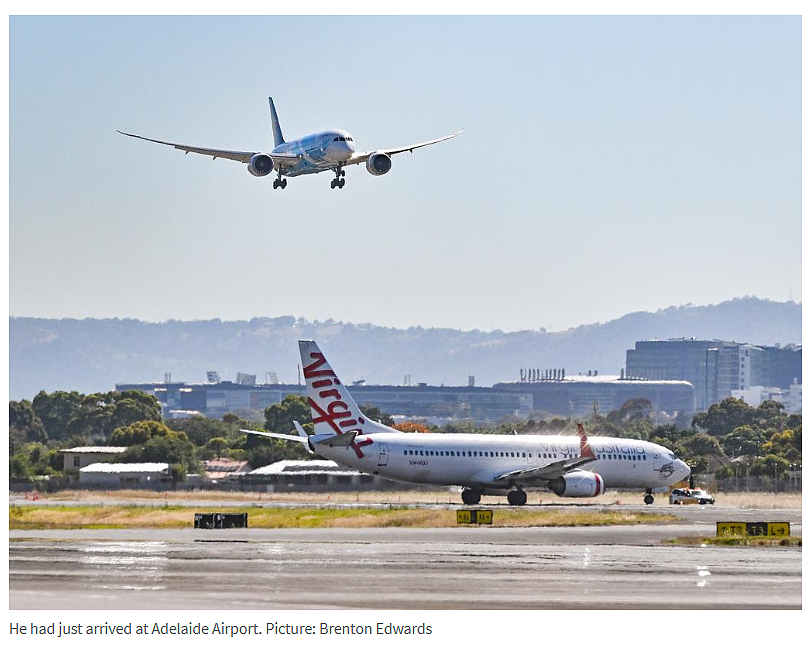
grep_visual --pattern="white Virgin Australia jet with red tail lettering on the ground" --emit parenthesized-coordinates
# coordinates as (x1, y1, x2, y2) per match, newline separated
(242, 341, 690, 506)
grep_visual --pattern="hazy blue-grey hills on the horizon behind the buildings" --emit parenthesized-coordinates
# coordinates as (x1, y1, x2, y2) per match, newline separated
(9, 297, 802, 399)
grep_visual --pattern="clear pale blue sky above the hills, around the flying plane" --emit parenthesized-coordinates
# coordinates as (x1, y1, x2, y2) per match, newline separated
(9, 17, 802, 330)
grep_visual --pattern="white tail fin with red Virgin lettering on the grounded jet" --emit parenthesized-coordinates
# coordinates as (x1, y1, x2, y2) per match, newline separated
(298, 341, 398, 436)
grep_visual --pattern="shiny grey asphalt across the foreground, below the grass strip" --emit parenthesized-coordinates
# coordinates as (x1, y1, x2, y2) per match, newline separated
(9, 505, 802, 610)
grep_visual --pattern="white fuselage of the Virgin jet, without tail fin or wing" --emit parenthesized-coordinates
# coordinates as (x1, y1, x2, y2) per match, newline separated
(310, 433, 690, 489)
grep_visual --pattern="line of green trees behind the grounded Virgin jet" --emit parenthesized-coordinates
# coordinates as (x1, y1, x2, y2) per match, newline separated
(9, 391, 802, 480)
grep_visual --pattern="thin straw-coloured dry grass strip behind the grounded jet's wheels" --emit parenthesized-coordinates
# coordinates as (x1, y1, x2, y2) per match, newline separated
(19, 489, 802, 509)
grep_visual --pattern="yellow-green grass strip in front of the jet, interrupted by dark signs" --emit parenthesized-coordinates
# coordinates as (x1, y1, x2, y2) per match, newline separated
(9, 505, 678, 529)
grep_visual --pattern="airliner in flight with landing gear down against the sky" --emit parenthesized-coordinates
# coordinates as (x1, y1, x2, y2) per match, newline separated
(118, 97, 463, 190)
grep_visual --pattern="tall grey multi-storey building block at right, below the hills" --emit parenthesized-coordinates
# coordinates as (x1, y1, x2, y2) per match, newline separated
(625, 339, 802, 411)
